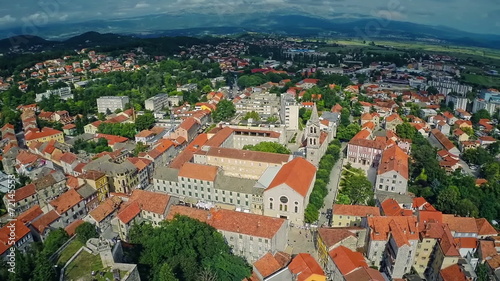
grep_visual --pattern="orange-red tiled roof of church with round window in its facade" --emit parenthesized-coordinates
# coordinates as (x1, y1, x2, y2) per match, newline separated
(266, 157, 316, 197)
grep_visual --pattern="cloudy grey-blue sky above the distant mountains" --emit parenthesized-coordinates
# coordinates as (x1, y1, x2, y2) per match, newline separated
(0, 0, 500, 34)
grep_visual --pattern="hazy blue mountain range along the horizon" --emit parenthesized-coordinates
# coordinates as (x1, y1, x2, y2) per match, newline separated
(0, 13, 500, 49)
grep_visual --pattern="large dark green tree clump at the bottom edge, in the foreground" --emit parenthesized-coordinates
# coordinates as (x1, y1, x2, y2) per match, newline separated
(130, 216, 251, 281)
